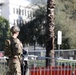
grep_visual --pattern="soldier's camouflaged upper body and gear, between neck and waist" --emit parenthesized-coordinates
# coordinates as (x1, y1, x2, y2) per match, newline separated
(4, 38, 21, 56)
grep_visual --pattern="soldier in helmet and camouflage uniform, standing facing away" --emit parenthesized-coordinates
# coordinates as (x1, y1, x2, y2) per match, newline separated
(4, 26, 23, 75)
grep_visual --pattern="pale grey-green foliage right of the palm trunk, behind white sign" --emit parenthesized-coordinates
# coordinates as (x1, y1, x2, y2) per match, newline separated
(55, 0, 76, 49)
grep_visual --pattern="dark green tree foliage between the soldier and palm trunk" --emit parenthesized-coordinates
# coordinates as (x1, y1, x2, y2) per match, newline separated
(19, 8, 46, 45)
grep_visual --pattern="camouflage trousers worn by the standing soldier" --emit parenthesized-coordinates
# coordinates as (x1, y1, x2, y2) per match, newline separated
(8, 58, 21, 75)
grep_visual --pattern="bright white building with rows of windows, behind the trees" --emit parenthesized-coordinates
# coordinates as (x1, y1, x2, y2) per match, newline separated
(0, 0, 33, 27)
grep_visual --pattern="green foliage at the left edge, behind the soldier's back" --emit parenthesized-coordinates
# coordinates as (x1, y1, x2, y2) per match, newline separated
(0, 16, 9, 50)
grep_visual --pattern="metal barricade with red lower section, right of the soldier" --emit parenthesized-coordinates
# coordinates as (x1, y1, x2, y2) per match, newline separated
(29, 57, 76, 75)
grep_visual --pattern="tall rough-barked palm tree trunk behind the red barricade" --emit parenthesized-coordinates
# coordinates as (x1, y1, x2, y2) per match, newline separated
(46, 0, 55, 66)
